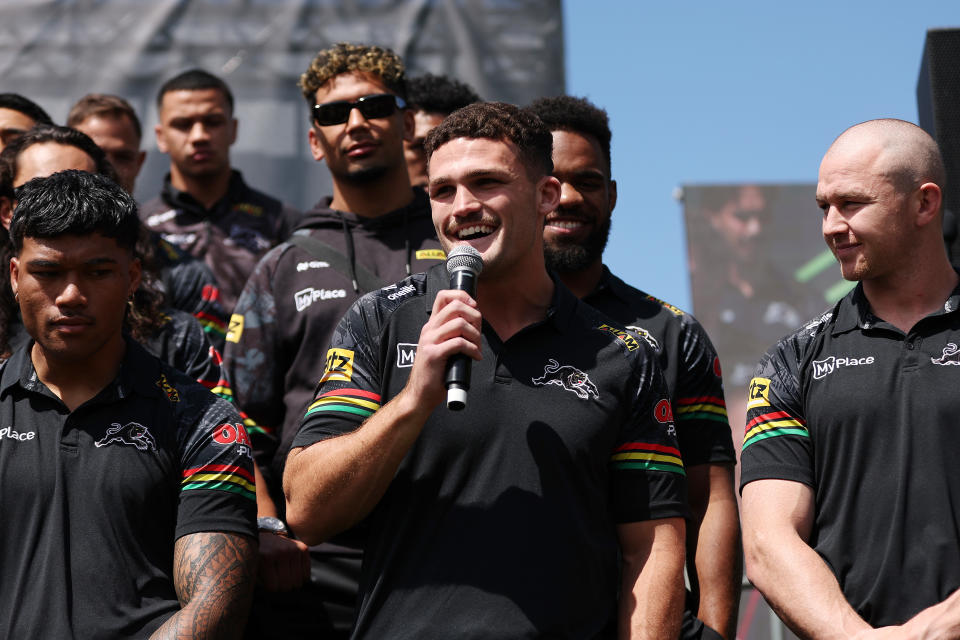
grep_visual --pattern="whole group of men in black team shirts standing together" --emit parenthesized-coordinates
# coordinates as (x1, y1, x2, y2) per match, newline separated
(0, 37, 960, 640)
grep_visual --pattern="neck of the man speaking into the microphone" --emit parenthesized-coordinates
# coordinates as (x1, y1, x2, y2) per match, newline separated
(477, 268, 554, 342)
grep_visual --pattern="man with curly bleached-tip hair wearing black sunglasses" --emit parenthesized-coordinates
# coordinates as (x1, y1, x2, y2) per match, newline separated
(224, 44, 444, 638)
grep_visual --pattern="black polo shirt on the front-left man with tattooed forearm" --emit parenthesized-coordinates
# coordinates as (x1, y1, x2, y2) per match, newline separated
(0, 340, 256, 640)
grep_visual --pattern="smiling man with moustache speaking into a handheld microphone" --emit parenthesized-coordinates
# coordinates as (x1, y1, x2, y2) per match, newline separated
(284, 103, 684, 638)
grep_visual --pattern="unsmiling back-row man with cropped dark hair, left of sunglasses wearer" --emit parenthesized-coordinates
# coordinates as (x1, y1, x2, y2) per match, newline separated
(140, 69, 298, 311)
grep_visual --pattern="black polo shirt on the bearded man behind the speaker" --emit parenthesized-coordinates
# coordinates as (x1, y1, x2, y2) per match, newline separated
(583, 266, 737, 468)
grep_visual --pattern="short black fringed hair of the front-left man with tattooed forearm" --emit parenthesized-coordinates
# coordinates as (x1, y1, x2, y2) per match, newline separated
(10, 169, 140, 255)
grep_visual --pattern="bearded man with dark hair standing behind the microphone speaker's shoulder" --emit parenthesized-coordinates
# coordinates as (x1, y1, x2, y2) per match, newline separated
(529, 96, 741, 640)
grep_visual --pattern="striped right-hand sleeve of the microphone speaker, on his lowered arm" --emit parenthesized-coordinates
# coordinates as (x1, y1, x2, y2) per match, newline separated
(611, 353, 687, 523)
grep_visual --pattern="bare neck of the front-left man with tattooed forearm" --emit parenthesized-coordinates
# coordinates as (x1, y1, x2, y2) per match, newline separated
(30, 334, 127, 411)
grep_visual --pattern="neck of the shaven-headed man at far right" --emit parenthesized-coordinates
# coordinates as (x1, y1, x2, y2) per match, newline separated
(863, 248, 958, 333)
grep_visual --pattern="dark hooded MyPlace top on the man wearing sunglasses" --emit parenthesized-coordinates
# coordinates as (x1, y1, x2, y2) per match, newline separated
(224, 189, 446, 482)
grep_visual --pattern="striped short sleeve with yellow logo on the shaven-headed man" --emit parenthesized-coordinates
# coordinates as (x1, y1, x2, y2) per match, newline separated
(740, 341, 814, 491)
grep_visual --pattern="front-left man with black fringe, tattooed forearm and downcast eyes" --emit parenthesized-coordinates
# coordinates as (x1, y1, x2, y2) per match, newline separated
(0, 171, 256, 639)
